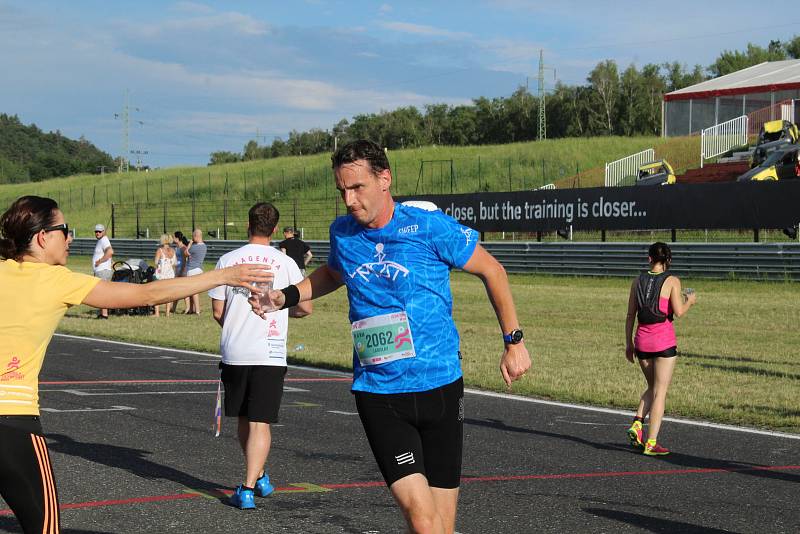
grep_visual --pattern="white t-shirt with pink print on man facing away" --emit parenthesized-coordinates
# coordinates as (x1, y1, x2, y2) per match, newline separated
(208, 243, 303, 366)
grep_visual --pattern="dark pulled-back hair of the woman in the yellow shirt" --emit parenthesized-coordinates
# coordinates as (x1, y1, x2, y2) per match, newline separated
(0, 196, 58, 260)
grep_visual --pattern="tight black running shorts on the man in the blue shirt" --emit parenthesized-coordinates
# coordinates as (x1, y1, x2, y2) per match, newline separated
(353, 378, 464, 489)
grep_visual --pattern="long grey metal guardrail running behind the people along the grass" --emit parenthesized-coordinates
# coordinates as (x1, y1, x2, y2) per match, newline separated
(71, 239, 800, 281)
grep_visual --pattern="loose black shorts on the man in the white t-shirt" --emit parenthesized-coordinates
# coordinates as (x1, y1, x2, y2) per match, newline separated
(219, 363, 286, 423)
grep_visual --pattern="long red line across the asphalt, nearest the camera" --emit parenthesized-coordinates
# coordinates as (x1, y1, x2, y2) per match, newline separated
(0, 465, 800, 516)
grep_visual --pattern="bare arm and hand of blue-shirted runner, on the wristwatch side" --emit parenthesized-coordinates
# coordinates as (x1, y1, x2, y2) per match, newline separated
(464, 245, 531, 387)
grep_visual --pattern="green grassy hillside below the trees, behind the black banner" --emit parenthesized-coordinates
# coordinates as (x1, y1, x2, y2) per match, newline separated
(0, 137, 699, 239)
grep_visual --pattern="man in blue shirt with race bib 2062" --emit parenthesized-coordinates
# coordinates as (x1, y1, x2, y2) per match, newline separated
(251, 140, 530, 533)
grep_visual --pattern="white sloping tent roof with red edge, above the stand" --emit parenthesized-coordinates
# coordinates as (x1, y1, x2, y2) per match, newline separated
(664, 59, 800, 100)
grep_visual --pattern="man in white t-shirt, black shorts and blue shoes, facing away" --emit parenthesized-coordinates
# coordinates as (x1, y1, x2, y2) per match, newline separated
(208, 202, 311, 510)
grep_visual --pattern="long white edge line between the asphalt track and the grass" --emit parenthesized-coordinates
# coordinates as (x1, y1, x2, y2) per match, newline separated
(55, 334, 800, 440)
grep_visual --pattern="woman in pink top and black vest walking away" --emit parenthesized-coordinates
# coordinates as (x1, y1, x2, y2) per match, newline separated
(625, 242, 697, 456)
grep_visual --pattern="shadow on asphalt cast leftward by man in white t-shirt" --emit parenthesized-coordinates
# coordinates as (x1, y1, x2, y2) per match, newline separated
(46, 434, 228, 505)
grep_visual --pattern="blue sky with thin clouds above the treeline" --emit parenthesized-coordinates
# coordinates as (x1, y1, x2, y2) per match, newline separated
(0, 0, 800, 167)
